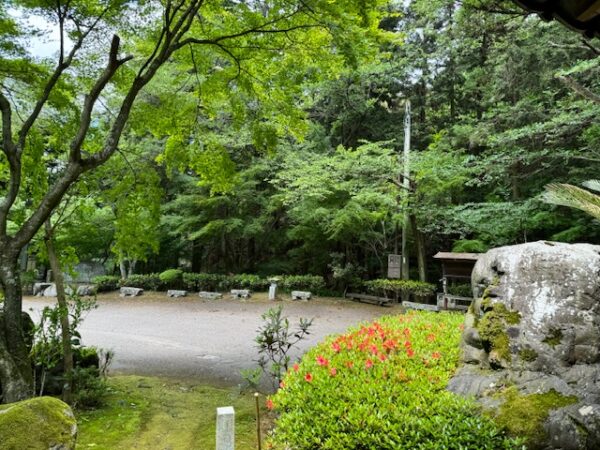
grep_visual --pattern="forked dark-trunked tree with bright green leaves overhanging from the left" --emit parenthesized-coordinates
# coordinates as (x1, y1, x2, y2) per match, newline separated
(0, 0, 390, 402)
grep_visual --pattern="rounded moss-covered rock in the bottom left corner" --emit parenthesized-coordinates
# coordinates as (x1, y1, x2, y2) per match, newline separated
(0, 397, 77, 450)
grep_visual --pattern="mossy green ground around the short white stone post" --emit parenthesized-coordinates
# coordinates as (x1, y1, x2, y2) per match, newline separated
(76, 376, 264, 450)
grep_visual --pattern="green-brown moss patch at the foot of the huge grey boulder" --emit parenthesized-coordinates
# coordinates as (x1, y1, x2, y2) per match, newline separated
(494, 386, 578, 450)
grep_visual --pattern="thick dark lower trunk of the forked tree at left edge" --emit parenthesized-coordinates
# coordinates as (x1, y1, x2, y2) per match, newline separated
(0, 250, 33, 403)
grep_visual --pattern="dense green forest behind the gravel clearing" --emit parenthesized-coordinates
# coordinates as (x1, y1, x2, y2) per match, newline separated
(4, 0, 600, 281)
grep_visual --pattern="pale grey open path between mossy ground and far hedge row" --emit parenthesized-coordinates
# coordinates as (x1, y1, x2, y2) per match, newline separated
(23, 293, 400, 386)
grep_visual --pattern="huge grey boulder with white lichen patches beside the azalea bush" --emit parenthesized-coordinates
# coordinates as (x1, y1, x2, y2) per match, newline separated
(449, 242, 600, 449)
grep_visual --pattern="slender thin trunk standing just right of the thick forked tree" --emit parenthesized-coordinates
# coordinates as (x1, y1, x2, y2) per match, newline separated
(45, 219, 74, 405)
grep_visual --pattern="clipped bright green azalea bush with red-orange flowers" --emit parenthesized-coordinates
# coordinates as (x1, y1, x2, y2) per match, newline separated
(267, 312, 519, 449)
